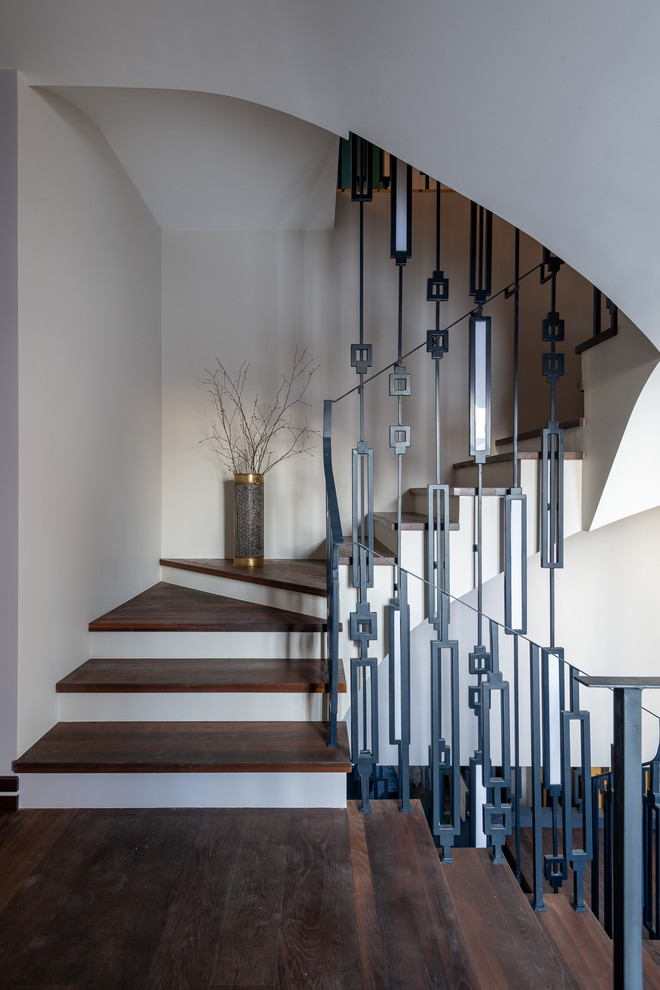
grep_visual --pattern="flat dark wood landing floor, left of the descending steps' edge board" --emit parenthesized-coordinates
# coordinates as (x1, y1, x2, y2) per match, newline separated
(0, 809, 362, 990)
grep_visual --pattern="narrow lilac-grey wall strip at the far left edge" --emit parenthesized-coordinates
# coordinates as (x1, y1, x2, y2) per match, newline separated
(0, 71, 18, 774)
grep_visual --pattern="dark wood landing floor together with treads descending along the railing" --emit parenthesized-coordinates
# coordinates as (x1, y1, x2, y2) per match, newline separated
(0, 801, 659, 990)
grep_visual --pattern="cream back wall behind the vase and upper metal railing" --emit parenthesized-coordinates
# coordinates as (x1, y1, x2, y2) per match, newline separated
(163, 191, 591, 557)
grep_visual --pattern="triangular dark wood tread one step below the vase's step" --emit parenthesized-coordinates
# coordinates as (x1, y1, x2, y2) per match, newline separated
(89, 581, 327, 632)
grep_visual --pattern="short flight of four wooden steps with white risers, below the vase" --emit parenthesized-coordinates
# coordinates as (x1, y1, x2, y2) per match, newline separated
(14, 559, 350, 807)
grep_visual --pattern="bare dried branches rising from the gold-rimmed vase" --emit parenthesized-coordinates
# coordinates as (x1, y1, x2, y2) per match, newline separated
(200, 347, 320, 474)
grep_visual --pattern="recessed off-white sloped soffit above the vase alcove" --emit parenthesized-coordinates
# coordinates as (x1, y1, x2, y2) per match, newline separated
(48, 86, 338, 230)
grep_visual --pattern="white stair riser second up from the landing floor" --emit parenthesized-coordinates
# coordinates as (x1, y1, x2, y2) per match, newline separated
(58, 692, 326, 722)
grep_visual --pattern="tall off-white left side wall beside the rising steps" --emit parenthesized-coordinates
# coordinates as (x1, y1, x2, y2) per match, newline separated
(18, 80, 160, 750)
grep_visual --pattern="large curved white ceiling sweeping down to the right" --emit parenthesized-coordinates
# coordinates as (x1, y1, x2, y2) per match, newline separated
(0, 0, 660, 341)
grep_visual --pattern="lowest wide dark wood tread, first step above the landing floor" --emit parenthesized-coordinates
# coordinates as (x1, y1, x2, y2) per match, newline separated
(14, 722, 351, 773)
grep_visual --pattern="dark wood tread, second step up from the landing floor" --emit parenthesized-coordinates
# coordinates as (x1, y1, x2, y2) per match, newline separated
(56, 658, 346, 694)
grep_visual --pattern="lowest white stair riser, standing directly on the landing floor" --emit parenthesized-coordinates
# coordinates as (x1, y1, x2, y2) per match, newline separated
(20, 773, 346, 808)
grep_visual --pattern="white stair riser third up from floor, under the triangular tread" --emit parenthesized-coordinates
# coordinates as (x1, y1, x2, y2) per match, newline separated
(90, 631, 325, 660)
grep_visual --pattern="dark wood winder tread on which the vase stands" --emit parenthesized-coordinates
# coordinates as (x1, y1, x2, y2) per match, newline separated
(160, 557, 327, 598)
